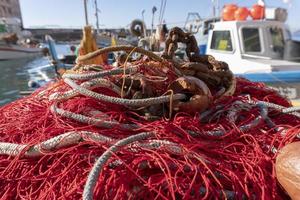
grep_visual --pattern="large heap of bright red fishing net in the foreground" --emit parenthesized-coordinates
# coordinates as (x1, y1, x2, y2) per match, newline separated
(0, 63, 299, 199)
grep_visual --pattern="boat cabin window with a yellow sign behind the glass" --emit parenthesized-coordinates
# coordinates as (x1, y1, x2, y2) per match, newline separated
(210, 31, 233, 51)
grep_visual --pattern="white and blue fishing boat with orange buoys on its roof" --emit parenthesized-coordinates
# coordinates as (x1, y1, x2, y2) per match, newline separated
(186, 4, 300, 104)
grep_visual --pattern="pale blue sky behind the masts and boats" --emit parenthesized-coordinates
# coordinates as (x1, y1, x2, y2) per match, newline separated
(20, 0, 300, 30)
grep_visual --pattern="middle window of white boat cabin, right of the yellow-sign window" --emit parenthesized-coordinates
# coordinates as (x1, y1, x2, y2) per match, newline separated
(242, 28, 261, 52)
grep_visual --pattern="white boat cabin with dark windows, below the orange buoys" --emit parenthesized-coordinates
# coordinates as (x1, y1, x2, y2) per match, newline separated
(206, 21, 300, 73)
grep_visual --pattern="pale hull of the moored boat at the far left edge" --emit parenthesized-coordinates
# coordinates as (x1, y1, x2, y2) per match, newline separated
(0, 45, 42, 61)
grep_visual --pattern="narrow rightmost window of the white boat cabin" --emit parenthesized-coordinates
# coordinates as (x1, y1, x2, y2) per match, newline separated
(269, 27, 284, 54)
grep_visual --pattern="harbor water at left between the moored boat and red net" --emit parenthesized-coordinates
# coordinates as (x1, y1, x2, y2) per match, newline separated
(0, 44, 70, 106)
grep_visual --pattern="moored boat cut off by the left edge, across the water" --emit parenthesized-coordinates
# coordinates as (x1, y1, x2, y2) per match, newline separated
(0, 18, 42, 61)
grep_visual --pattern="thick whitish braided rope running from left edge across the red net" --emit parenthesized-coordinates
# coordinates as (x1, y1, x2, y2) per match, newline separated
(0, 131, 188, 158)
